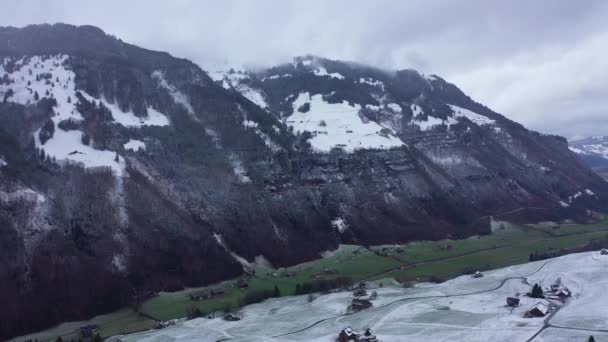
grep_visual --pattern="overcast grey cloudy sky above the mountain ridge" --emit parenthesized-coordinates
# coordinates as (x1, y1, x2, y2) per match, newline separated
(0, 0, 608, 137)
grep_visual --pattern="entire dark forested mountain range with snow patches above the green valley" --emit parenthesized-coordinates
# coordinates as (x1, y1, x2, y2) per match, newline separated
(0, 24, 608, 337)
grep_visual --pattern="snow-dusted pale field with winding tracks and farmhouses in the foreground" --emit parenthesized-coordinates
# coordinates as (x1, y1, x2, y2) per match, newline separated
(114, 252, 608, 342)
